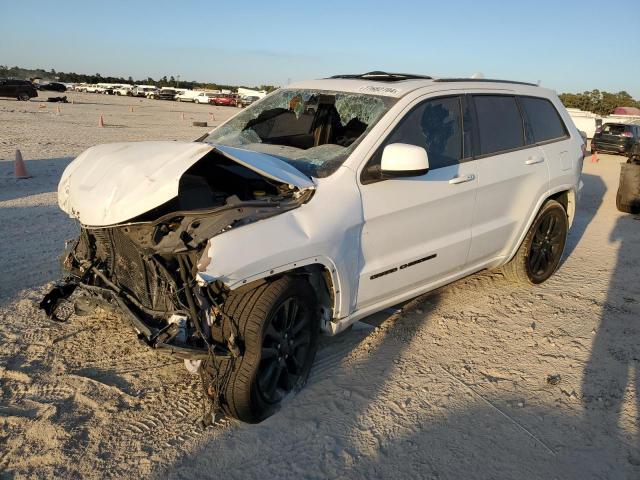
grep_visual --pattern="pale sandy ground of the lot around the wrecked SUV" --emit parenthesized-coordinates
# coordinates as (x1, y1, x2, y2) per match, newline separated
(0, 94, 640, 479)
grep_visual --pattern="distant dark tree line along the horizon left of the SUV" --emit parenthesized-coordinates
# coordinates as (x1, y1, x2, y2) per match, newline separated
(0, 65, 277, 92)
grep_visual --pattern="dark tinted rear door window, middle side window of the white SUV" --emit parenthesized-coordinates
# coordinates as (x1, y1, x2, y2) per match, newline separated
(473, 95, 524, 155)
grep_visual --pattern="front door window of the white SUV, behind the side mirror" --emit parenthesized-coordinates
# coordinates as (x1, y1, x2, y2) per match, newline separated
(378, 97, 463, 170)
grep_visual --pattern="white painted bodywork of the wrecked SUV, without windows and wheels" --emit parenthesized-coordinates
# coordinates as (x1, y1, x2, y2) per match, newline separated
(59, 79, 582, 333)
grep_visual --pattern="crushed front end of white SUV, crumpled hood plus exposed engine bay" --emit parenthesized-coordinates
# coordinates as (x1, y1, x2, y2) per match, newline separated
(40, 143, 313, 424)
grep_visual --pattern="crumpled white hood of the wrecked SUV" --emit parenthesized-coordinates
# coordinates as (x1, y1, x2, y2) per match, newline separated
(58, 142, 315, 226)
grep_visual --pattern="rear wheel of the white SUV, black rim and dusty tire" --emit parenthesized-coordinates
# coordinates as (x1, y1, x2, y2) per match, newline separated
(502, 200, 569, 285)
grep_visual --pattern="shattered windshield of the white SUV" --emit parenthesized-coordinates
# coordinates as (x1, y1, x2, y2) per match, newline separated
(204, 89, 396, 177)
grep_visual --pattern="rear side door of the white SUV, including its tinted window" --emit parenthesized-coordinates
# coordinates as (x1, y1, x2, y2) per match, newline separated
(468, 94, 549, 266)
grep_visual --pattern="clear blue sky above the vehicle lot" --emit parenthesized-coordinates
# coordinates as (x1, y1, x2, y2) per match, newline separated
(0, 0, 640, 99)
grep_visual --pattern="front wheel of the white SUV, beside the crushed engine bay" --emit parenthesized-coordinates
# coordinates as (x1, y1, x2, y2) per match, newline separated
(203, 276, 320, 423)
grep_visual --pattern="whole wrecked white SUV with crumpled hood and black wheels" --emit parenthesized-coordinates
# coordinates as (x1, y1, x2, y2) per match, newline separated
(41, 72, 583, 422)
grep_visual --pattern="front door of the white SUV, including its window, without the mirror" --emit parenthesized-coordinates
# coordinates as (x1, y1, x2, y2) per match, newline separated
(357, 96, 477, 308)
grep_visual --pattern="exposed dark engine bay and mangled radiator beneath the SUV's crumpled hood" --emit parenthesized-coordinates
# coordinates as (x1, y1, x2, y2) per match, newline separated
(41, 150, 313, 424)
